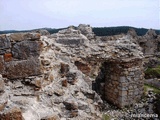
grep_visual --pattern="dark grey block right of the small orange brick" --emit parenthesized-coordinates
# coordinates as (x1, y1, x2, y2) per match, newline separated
(12, 41, 41, 60)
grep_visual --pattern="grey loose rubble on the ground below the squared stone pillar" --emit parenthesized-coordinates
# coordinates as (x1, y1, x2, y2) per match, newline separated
(104, 91, 158, 120)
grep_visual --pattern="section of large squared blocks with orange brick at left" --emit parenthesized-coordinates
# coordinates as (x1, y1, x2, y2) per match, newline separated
(0, 33, 42, 79)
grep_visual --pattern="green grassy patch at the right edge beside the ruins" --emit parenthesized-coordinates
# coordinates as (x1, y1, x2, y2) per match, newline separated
(145, 65, 160, 78)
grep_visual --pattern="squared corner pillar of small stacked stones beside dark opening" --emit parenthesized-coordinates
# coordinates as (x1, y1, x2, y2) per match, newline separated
(105, 60, 144, 108)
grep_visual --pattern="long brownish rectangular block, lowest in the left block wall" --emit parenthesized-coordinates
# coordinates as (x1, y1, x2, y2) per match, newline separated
(3, 58, 41, 79)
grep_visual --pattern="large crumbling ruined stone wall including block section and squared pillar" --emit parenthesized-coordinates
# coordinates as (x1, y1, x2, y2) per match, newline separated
(0, 25, 155, 120)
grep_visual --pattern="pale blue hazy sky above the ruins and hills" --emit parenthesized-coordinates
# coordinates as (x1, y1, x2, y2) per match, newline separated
(0, 0, 160, 30)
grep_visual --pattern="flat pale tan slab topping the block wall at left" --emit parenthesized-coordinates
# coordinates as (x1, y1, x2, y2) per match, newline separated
(10, 33, 40, 42)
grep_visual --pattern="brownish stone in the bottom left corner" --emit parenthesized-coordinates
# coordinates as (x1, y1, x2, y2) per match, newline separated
(0, 108, 24, 120)
